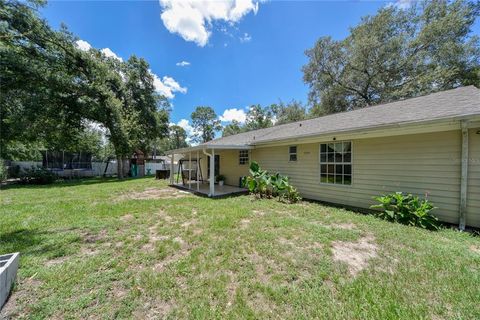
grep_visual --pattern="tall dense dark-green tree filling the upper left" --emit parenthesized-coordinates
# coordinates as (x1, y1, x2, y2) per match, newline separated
(0, 0, 168, 177)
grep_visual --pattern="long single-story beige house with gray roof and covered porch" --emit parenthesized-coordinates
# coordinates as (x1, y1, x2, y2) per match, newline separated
(167, 86, 480, 229)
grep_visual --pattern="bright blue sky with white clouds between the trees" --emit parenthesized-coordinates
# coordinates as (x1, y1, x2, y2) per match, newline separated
(41, 0, 480, 133)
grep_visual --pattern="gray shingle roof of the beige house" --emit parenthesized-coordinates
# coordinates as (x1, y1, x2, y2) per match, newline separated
(184, 86, 480, 147)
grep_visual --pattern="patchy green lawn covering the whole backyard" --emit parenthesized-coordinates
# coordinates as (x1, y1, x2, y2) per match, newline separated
(0, 178, 480, 319)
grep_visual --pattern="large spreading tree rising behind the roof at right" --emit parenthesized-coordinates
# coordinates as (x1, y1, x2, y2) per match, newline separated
(303, 0, 480, 115)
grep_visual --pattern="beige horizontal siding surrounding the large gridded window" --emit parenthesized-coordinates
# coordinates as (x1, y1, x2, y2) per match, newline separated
(252, 130, 468, 225)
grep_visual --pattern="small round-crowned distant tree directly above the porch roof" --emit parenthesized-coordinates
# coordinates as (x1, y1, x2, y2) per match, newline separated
(191, 106, 222, 143)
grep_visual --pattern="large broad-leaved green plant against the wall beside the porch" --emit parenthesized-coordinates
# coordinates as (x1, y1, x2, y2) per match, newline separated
(242, 161, 302, 203)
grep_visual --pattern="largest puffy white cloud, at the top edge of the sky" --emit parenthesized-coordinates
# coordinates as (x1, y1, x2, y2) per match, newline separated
(159, 0, 258, 47)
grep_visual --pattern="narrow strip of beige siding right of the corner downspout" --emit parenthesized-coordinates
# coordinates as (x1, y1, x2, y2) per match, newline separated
(466, 127, 480, 227)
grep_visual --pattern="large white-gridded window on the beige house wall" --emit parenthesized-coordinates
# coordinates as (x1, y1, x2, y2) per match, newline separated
(320, 141, 352, 185)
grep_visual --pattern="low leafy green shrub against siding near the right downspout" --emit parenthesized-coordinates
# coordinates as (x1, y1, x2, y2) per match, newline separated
(371, 192, 440, 230)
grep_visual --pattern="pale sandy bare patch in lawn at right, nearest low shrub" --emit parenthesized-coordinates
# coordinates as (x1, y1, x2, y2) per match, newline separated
(332, 235, 378, 276)
